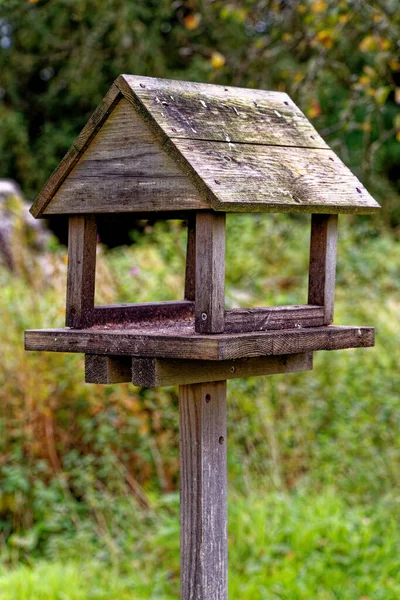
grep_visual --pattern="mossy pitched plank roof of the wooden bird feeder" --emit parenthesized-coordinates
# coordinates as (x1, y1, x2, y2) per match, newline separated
(31, 75, 379, 217)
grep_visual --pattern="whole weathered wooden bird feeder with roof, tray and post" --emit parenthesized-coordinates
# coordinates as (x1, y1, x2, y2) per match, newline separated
(25, 75, 379, 600)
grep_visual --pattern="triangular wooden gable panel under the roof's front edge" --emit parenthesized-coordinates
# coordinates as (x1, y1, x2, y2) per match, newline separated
(45, 99, 209, 214)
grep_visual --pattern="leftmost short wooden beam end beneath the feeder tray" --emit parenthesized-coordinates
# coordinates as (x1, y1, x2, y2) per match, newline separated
(85, 354, 132, 383)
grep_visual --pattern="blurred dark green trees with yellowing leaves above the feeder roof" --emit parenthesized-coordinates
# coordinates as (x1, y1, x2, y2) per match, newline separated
(0, 0, 400, 226)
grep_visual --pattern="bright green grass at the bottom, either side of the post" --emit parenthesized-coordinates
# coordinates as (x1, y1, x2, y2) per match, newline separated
(0, 491, 400, 600)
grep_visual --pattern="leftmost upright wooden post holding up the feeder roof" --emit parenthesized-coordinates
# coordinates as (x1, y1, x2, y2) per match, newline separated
(66, 215, 97, 328)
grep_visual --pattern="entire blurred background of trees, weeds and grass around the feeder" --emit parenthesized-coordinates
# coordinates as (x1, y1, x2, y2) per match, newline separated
(0, 0, 400, 600)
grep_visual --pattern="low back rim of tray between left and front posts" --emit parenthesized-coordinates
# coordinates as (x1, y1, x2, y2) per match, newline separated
(93, 300, 194, 325)
